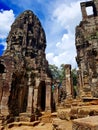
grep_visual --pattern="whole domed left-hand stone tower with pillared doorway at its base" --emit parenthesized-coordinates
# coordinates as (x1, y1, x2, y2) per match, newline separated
(0, 10, 52, 116)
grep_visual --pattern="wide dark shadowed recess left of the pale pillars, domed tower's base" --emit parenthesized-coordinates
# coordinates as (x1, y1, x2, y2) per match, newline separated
(8, 72, 28, 116)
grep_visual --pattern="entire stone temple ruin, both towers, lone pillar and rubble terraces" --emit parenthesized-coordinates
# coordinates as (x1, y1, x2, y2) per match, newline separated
(0, 0, 98, 130)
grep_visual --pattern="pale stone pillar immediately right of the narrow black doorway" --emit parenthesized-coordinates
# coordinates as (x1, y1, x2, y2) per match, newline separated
(45, 79, 52, 112)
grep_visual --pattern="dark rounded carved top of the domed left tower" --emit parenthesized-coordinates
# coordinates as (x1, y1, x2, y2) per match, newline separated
(7, 11, 46, 55)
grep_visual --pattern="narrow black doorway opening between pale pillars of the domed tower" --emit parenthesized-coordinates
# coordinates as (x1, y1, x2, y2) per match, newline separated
(38, 81, 46, 111)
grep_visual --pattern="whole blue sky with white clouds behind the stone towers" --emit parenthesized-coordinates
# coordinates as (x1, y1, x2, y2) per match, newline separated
(0, 0, 91, 68)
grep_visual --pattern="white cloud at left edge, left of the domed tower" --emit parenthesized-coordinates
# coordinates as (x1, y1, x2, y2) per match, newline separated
(0, 10, 15, 39)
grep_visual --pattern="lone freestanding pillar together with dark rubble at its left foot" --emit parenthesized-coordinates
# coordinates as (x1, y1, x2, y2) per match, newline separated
(59, 64, 74, 105)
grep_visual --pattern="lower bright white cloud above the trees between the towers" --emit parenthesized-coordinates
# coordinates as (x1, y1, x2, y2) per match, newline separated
(46, 27, 77, 68)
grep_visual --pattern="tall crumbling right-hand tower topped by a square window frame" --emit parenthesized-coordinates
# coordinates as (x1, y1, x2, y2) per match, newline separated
(76, 0, 98, 98)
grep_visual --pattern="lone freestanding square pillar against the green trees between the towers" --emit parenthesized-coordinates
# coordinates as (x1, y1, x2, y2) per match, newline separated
(65, 64, 73, 98)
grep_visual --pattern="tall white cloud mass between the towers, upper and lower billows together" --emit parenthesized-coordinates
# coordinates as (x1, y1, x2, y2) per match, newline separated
(46, 0, 82, 68)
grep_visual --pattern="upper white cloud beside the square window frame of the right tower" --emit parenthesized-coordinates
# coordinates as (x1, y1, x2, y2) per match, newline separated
(53, 1, 82, 31)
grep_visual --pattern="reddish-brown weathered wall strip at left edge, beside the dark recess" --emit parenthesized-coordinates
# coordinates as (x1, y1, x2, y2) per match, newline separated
(0, 56, 13, 114)
